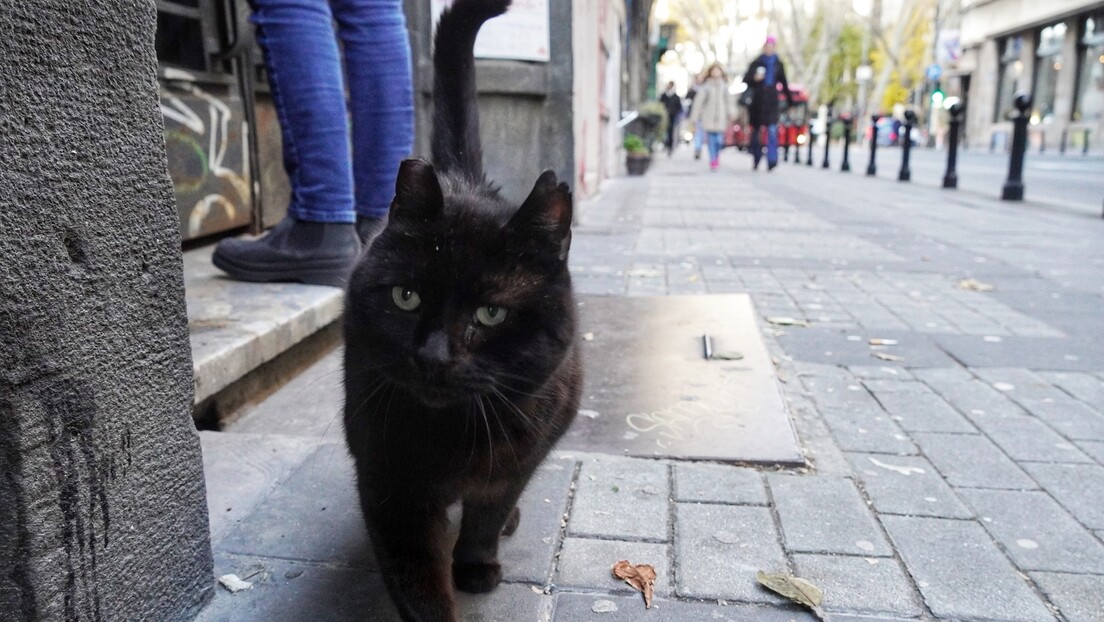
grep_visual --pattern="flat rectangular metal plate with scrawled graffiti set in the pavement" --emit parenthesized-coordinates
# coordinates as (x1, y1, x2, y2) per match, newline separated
(559, 294, 804, 465)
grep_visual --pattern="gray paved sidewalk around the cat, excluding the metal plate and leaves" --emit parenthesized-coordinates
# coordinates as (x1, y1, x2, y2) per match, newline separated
(201, 148, 1104, 622)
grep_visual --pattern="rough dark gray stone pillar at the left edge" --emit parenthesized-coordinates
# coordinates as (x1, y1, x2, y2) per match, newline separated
(0, 0, 213, 622)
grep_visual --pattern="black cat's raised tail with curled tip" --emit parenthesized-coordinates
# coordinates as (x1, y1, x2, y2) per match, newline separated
(432, 0, 510, 183)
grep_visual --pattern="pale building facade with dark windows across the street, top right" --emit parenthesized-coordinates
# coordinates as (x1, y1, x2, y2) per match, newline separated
(956, 0, 1104, 152)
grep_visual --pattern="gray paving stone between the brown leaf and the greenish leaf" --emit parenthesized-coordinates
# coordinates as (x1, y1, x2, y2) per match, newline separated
(675, 504, 786, 603)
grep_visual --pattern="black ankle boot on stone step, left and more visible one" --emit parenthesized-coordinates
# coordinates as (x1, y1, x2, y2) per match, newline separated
(211, 217, 360, 287)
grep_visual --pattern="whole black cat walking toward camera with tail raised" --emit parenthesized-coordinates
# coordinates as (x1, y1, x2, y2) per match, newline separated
(344, 0, 582, 621)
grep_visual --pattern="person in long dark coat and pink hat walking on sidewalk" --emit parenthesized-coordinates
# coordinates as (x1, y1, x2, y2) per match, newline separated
(744, 36, 794, 170)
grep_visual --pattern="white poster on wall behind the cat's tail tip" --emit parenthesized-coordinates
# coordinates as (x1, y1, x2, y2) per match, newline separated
(429, 0, 551, 62)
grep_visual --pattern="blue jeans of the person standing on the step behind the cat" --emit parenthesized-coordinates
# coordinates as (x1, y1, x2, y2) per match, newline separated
(253, 0, 414, 222)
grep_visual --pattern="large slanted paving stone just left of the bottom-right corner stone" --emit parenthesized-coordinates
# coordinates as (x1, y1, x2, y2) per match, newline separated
(882, 516, 1054, 622)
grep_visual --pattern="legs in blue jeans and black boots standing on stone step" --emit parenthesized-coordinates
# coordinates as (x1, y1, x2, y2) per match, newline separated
(207, 0, 414, 286)
